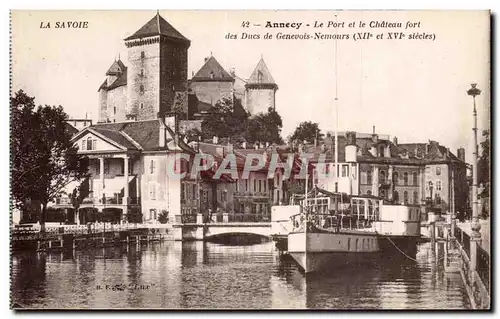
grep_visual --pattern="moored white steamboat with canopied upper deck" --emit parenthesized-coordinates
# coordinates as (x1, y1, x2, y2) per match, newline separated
(275, 187, 420, 273)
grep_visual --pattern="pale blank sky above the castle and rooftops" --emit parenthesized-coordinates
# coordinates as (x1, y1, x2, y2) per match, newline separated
(11, 10, 490, 162)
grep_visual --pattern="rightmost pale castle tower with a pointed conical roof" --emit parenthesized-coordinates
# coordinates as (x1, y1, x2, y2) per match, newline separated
(245, 58, 278, 115)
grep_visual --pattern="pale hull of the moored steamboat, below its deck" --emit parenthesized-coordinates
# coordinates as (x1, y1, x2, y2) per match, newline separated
(288, 231, 418, 273)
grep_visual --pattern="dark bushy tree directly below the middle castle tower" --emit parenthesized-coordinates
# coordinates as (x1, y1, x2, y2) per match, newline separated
(201, 97, 250, 139)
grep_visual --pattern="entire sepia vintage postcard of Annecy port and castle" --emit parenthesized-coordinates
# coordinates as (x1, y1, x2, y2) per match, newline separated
(10, 10, 492, 310)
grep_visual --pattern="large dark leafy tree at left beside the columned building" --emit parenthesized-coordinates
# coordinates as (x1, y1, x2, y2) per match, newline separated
(11, 91, 88, 231)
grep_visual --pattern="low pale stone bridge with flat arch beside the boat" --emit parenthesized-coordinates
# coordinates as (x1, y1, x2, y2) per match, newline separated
(173, 216, 271, 240)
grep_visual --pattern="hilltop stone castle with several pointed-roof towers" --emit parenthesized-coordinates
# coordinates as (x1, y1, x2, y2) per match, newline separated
(98, 13, 278, 123)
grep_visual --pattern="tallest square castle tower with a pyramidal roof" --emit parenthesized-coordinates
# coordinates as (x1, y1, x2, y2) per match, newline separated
(125, 13, 191, 120)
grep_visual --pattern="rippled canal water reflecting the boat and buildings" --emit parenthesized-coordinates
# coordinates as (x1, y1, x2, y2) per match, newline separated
(11, 242, 470, 309)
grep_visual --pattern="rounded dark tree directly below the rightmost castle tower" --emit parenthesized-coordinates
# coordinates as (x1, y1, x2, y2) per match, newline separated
(246, 108, 283, 144)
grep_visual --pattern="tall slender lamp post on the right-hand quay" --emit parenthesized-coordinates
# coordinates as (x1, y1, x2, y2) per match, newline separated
(467, 83, 481, 237)
